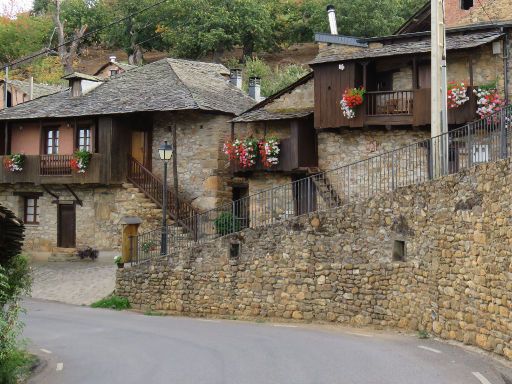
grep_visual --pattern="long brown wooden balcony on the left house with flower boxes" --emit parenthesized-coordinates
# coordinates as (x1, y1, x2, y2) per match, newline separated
(0, 153, 107, 184)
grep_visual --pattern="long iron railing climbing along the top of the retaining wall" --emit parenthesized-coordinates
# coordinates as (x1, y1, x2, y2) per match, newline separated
(132, 106, 512, 263)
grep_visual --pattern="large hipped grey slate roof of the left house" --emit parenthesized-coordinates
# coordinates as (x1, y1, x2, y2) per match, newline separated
(0, 59, 255, 120)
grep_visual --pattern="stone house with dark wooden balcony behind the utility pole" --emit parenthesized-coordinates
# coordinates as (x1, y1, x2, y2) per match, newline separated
(233, 0, 512, 212)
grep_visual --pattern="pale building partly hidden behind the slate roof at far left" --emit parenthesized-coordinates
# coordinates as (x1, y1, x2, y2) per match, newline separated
(0, 80, 63, 109)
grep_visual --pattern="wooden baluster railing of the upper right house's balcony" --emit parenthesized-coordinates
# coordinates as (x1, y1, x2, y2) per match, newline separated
(366, 90, 414, 116)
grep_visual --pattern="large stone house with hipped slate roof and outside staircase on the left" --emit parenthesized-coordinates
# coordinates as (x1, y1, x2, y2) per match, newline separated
(0, 59, 254, 252)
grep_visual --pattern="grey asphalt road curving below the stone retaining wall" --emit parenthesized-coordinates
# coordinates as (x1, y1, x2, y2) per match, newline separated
(25, 300, 512, 384)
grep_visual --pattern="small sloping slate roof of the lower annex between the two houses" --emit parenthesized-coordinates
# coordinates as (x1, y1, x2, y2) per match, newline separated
(232, 72, 314, 123)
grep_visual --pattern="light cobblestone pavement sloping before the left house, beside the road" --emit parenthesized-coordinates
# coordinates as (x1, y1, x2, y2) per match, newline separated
(32, 255, 116, 305)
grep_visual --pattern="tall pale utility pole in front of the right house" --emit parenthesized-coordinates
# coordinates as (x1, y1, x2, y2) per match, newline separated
(430, 0, 448, 176)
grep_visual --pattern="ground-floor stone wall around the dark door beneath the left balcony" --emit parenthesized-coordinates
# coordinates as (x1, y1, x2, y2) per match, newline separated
(0, 184, 161, 253)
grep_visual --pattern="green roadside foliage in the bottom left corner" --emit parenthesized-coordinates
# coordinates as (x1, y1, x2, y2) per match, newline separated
(0, 256, 31, 384)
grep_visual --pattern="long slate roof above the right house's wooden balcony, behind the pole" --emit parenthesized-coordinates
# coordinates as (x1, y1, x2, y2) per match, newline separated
(310, 32, 503, 64)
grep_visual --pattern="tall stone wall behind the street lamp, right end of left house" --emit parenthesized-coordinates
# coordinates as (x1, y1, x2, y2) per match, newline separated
(152, 112, 232, 211)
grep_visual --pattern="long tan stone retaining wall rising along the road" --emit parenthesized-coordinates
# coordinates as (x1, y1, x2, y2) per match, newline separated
(116, 160, 512, 358)
